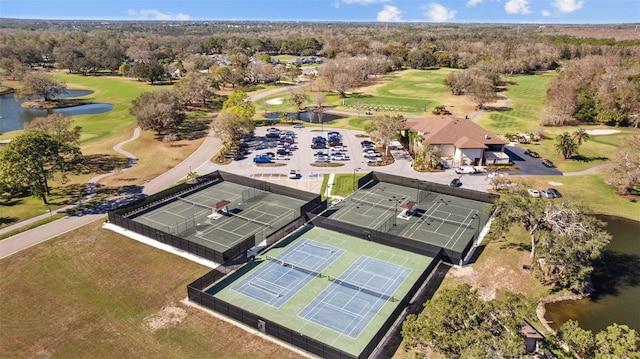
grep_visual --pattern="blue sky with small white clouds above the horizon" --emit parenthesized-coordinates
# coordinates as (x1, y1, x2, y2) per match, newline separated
(0, 0, 640, 24)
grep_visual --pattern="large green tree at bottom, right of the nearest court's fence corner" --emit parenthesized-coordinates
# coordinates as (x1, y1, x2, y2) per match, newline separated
(402, 284, 531, 359)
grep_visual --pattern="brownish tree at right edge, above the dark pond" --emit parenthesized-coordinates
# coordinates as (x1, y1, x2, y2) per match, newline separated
(607, 135, 640, 195)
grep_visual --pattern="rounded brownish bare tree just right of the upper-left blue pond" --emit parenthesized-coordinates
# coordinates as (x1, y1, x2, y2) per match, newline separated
(129, 89, 184, 134)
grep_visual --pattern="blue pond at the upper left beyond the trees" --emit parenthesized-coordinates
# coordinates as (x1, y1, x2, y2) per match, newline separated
(0, 90, 113, 133)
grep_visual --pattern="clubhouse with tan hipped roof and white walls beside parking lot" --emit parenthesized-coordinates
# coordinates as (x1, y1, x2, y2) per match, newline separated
(405, 115, 509, 167)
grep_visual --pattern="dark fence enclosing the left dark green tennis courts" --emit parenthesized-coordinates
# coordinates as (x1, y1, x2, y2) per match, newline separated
(108, 171, 327, 263)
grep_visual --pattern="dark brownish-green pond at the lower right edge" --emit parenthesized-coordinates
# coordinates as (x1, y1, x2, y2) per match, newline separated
(545, 216, 640, 333)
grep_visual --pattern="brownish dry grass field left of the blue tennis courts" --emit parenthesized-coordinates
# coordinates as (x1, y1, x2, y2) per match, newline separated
(0, 221, 299, 358)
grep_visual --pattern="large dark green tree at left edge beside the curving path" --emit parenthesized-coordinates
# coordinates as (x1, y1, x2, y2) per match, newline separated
(0, 132, 80, 204)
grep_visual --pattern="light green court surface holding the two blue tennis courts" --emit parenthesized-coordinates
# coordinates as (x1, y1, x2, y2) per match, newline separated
(207, 227, 433, 357)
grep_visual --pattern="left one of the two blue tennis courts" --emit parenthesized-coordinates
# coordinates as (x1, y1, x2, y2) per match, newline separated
(232, 239, 344, 308)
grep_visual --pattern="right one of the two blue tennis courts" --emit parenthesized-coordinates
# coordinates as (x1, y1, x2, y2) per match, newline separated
(298, 256, 411, 338)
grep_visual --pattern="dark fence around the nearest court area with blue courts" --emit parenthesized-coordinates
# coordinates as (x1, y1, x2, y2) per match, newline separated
(187, 243, 442, 359)
